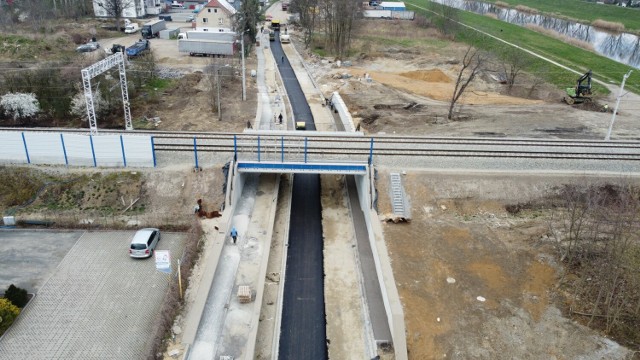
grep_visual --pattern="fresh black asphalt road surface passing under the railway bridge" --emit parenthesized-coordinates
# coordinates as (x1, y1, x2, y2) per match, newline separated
(271, 33, 328, 360)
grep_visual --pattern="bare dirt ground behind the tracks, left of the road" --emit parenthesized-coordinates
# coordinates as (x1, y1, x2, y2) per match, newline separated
(65, 31, 257, 132)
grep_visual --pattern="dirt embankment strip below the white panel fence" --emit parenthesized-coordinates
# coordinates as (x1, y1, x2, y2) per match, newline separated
(0, 165, 225, 229)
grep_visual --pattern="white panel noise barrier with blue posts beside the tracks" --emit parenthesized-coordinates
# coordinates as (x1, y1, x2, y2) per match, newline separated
(0, 131, 156, 167)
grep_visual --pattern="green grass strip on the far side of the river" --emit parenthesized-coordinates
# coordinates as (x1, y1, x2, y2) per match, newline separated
(485, 0, 640, 33)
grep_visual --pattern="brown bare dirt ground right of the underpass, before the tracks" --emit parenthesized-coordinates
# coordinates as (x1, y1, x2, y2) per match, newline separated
(378, 171, 631, 359)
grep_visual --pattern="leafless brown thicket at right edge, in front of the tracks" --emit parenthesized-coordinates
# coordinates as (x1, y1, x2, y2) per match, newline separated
(551, 184, 640, 342)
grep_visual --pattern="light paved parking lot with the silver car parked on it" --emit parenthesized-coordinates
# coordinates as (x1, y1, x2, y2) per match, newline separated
(0, 231, 184, 359)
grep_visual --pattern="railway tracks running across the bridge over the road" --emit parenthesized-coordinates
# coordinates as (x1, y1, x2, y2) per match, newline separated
(5, 128, 640, 161)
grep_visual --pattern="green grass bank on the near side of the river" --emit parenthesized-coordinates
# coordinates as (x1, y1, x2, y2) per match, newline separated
(406, 0, 640, 94)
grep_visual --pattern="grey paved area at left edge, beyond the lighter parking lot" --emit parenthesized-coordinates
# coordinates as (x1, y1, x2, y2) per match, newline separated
(0, 230, 83, 293)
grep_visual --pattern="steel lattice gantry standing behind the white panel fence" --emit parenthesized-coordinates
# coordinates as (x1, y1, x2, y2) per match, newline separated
(81, 52, 133, 135)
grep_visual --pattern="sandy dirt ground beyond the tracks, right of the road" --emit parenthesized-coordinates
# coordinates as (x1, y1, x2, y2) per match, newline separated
(299, 20, 640, 139)
